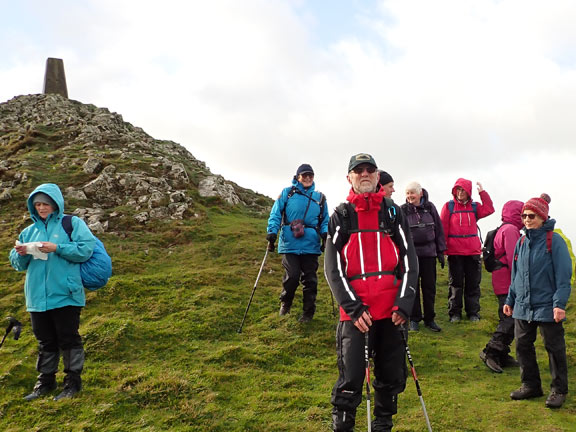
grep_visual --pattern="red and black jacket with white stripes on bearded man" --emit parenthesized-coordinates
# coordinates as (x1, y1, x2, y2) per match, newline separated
(324, 191, 418, 321)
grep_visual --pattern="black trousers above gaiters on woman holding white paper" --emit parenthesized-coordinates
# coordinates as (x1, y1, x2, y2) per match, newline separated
(30, 306, 82, 352)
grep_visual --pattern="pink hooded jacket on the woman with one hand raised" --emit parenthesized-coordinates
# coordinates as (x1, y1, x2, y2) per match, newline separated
(440, 178, 494, 255)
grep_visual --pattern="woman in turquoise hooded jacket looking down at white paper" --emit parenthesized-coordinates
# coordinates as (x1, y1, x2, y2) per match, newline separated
(10, 183, 95, 401)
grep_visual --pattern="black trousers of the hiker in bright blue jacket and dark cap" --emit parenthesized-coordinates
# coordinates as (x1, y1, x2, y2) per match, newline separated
(280, 254, 318, 316)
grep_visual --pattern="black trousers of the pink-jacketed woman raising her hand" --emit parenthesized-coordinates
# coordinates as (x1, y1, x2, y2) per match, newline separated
(448, 255, 482, 317)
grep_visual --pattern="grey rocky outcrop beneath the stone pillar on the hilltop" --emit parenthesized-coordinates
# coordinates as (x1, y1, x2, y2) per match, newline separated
(0, 94, 271, 232)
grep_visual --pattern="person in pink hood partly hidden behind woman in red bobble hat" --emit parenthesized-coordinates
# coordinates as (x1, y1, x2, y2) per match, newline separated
(480, 200, 524, 373)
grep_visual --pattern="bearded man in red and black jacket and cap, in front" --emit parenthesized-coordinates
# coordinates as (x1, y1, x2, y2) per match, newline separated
(324, 153, 418, 432)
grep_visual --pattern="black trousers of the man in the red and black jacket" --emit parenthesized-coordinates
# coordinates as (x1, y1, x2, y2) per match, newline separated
(331, 318, 407, 431)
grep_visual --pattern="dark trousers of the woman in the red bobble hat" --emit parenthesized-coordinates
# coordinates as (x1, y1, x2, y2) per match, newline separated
(514, 319, 568, 394)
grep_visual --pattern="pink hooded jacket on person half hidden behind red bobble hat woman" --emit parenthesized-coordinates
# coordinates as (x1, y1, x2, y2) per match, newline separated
(492, 200, 524, 295)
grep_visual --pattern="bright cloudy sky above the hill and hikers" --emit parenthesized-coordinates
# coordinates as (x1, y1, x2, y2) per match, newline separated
(0, 0, 576, 242)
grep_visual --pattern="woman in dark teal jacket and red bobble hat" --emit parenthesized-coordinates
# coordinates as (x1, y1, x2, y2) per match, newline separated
(503, 194, 572, 408)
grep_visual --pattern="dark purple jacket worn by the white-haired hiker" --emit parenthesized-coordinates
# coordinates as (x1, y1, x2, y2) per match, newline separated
(401, 189, 446, 257)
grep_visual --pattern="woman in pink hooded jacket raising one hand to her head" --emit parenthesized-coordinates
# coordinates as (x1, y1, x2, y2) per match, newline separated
(440, 178, 494, 322)
